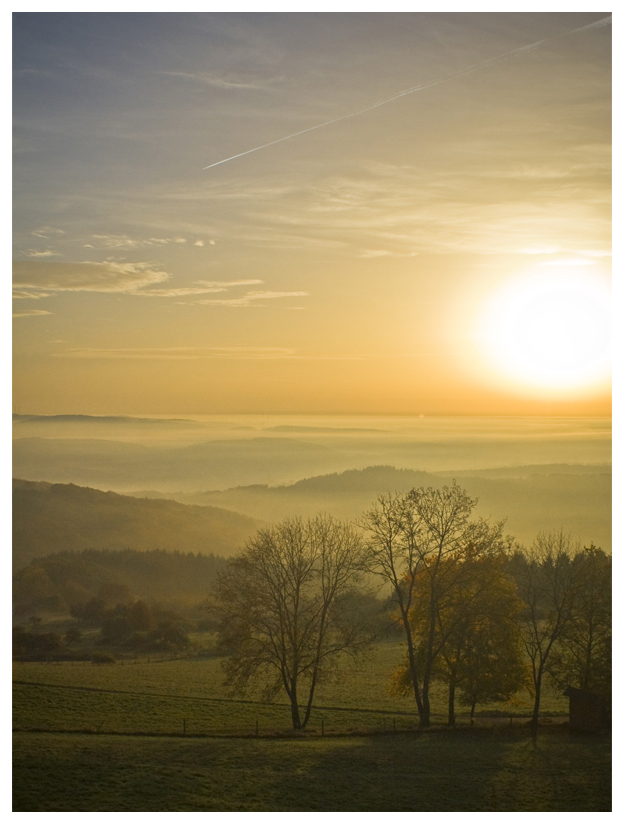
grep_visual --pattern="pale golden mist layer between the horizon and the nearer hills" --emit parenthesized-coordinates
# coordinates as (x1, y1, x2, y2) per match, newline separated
(13, 415, 611, 482)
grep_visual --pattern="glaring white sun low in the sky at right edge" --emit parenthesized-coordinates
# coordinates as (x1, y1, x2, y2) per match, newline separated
(478, 271, 610, 391)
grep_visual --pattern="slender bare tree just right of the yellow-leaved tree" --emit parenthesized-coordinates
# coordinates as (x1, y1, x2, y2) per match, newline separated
(517, 530, 582, 725)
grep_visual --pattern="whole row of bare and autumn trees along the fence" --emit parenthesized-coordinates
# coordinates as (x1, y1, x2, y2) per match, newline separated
(206, 482, 611, 730)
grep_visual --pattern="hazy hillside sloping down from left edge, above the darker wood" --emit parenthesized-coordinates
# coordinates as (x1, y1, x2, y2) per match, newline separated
(13, 479, 261, 569)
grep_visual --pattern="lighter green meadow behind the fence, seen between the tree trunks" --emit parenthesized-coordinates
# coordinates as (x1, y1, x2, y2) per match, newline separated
(14, 642, 568, 733)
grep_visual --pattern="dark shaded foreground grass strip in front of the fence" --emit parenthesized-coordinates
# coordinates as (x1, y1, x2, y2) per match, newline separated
(13, 726, 610, 812)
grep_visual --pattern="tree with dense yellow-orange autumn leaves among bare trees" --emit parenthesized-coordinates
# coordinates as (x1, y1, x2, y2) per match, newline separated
(395, 543, 525, 725)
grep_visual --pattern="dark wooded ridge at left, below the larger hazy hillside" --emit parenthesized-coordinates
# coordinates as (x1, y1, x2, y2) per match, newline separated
(13, 550, 226, 616)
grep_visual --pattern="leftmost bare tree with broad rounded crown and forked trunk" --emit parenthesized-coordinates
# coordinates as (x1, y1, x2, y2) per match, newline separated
(214, 515, 369, 729)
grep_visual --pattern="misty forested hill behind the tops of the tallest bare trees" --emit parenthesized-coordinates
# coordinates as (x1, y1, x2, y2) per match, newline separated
(165, 465, 612, 552)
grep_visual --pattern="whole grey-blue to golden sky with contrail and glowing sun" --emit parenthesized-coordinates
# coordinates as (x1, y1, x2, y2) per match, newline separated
(13, 12, 612, 415)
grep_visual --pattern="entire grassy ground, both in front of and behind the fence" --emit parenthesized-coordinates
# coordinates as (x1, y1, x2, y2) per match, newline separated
(13, 643, 610, 811)
